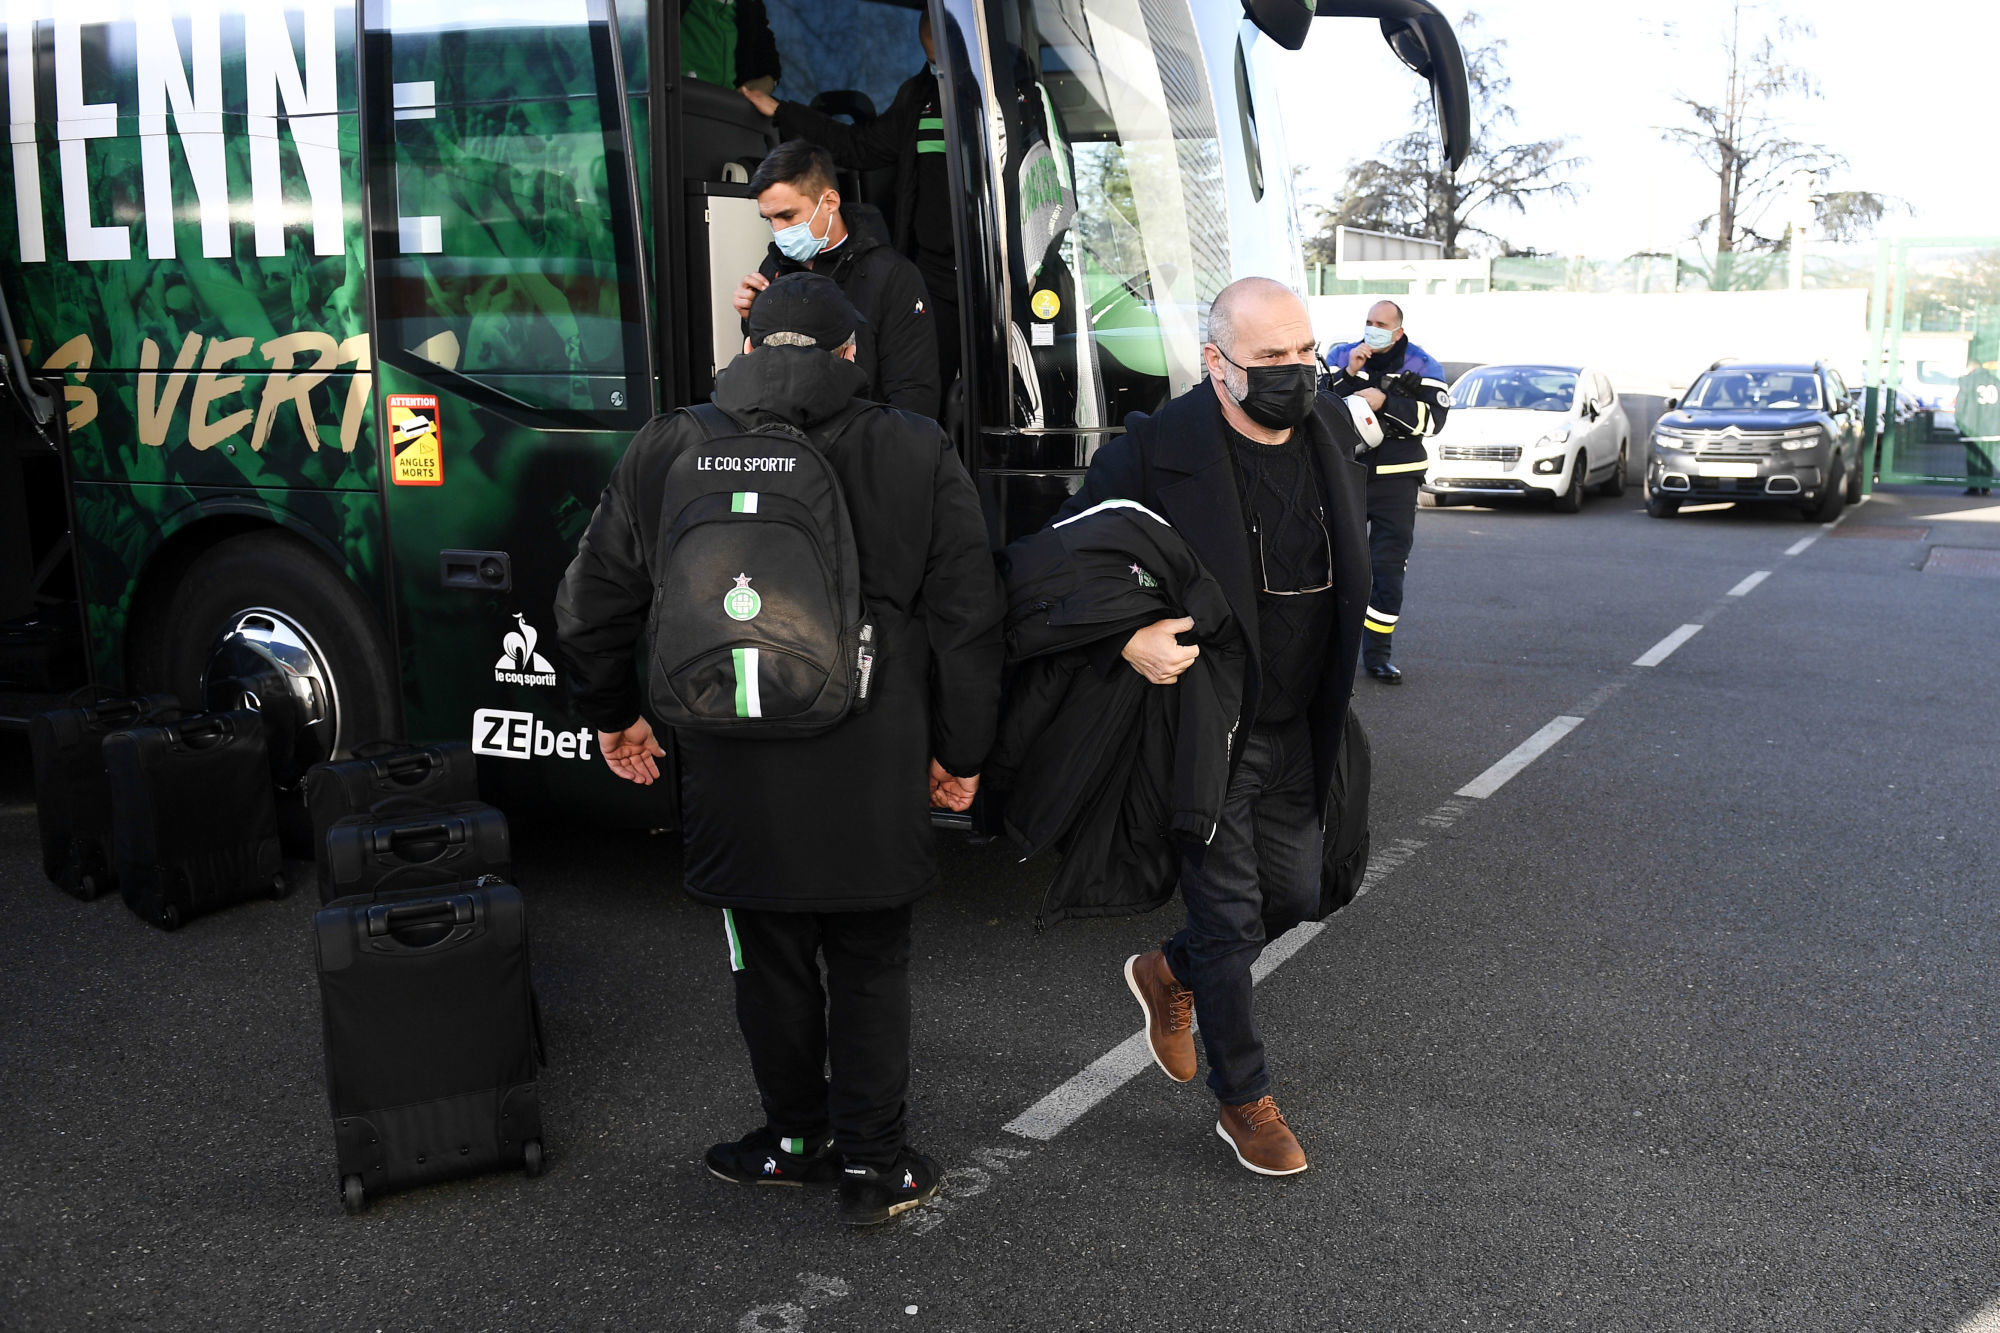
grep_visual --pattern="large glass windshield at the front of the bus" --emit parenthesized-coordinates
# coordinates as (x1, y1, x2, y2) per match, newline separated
(986, 0, 1230, 428)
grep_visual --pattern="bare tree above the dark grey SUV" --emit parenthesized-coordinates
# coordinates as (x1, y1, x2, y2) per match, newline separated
(1660, 0, 1898, 254)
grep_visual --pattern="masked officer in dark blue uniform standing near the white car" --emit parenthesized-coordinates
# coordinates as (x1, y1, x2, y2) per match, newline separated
(1326, 300, 1450, 685)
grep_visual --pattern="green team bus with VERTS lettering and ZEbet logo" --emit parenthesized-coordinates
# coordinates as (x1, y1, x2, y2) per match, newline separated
(0, 0, 1466, 825)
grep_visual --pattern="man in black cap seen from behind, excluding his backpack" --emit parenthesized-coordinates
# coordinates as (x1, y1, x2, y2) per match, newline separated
(556, 272, 1002, 1225)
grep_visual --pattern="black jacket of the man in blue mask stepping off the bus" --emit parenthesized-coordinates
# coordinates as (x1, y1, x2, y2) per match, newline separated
(758, 204, 942, 418)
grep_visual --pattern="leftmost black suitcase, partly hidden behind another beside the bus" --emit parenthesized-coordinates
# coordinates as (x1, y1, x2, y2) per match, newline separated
(28, 695, 180, 899)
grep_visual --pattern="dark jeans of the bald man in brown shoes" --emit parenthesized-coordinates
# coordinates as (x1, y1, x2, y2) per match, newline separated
(1166, 719, 1320, 1105)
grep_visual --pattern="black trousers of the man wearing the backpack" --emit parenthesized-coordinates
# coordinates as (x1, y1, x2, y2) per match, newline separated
(722, 907, 910, 1167)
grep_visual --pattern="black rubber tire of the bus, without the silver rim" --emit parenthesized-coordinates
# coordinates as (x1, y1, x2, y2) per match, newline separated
(140, 530, 400, 761)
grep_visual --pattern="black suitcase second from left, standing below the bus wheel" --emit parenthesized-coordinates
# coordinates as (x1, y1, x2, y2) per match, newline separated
(104, 711, 284, 931)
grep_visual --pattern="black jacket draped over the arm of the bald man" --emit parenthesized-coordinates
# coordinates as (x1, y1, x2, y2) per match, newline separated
(988, 500, 1246, 925)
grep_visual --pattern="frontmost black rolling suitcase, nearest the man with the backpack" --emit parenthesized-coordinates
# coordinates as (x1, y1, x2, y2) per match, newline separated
(312, 879, 542, 1213)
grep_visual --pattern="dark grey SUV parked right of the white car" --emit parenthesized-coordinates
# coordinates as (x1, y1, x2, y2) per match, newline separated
(1646, 360, 1866, 522)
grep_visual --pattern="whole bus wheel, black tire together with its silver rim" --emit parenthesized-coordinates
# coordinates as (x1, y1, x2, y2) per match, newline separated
(146, 532, 398, 764)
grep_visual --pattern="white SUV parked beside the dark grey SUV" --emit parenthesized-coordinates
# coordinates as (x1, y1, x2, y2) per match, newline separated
(1420, 366, 1632, 514)
